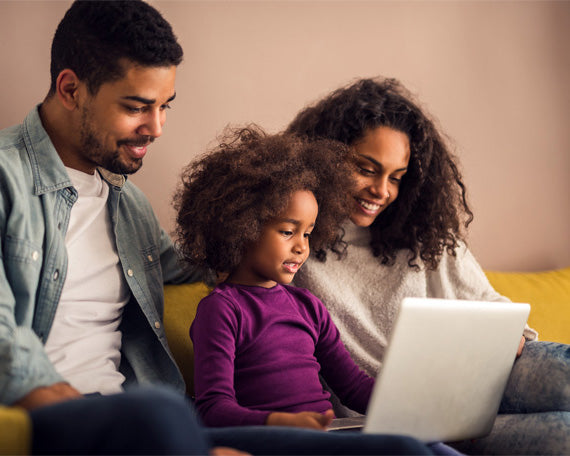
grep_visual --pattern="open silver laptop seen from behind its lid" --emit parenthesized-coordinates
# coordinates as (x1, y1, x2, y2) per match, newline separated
(329, 298, 530, 442)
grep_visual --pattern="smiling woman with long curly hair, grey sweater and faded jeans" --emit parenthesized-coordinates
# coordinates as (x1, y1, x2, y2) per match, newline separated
(287, 79, 570, 453)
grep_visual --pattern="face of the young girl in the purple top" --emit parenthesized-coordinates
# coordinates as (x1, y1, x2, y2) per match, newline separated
(228, 190, 319, 288)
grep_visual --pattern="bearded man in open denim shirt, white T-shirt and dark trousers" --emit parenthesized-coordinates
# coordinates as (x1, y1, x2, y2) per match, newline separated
(0, 0, 430, 454)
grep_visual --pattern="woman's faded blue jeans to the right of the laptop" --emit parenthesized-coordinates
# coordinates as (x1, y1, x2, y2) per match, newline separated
(453, 342, 570, 454)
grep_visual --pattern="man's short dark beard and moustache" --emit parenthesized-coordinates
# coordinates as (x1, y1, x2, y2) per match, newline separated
(80, 108, 148, 174)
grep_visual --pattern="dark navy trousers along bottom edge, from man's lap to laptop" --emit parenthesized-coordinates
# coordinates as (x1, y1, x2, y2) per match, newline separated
(30, 388, 430, 455)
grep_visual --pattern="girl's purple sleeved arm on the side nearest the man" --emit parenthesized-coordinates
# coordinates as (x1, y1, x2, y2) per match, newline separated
(190, 292, 270, 426)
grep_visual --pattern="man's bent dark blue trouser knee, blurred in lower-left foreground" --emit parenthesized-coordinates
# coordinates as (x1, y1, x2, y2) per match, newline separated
(30, 388, 209, 455)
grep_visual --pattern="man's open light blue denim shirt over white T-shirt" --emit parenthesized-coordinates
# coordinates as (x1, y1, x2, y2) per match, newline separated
(0, 107, 204, 404)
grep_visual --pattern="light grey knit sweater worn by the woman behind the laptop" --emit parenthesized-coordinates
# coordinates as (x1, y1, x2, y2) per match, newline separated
(295, 222, 537, 376)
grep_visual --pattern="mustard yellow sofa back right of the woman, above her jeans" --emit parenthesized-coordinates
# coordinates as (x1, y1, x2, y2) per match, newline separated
(486, 267, 570, 344)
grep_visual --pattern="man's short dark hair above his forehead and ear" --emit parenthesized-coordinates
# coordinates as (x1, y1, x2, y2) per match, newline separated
(49, 0, 183, 95)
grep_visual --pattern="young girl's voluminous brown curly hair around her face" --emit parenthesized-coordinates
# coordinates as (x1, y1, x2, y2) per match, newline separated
(174, 125, 354, 273)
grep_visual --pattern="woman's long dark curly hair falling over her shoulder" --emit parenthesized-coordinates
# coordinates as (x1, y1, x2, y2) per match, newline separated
(287, 79, 473, 269)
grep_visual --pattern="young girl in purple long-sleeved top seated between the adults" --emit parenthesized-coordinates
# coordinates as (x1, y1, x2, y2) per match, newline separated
(171, 128, 374, 429)
